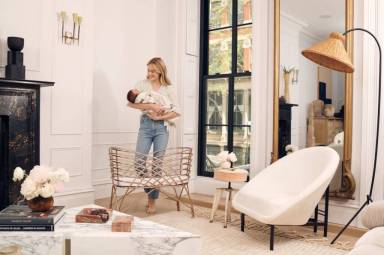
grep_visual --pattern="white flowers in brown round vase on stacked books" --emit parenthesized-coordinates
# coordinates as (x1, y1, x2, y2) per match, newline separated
(13, 166, 69, 212)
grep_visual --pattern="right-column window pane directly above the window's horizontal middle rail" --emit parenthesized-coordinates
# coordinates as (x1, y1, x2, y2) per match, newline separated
(237, 25, 252, 73)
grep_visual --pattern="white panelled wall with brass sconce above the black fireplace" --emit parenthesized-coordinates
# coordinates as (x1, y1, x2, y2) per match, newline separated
(0, 0, 93, 206)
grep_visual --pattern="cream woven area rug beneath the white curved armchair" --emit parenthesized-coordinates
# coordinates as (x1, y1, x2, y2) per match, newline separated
(145, 206, 351, 255)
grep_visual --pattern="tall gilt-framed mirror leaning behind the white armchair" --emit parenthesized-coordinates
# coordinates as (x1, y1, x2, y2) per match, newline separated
(272, 0, 355, 199)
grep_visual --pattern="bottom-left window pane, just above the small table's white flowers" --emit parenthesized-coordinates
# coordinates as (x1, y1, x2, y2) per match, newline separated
(205, 127, 228, 172)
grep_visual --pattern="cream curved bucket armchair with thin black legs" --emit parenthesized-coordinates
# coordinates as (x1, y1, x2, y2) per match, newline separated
(233, 147, 339, 250)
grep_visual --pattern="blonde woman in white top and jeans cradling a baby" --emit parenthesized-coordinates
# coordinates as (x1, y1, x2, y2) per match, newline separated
(129, 58, 180, 214)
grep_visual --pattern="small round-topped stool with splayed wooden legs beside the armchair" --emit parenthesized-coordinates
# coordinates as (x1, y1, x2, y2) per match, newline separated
(209, 169, 248, 228)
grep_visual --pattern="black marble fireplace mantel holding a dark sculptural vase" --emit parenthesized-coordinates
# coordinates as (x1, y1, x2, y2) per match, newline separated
(0, 78, 54, 208)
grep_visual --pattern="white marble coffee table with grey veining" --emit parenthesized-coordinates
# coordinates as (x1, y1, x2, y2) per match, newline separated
(0, 205, 201, 255)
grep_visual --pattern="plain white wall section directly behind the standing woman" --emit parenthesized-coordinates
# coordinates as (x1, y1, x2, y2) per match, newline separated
(92, 0, 180, 198)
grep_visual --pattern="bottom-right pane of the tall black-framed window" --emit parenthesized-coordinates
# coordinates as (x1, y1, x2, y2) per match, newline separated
(233, 127, 251, 166)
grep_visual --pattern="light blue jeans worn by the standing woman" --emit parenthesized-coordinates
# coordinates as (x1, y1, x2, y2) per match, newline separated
(136, 115, 169, 199)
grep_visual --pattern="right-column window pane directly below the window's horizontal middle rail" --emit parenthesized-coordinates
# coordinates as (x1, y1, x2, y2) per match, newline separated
(233, 76, 252, 127)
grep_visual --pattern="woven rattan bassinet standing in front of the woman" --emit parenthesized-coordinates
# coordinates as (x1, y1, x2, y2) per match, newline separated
(109, 147, 195, 217)
